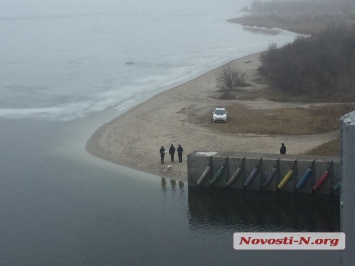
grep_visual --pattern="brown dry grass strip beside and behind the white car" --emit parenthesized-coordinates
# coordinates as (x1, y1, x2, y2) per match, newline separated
(190, 104, 355, 135)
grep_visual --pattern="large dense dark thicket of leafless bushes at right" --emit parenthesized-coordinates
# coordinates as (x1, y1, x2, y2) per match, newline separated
(259, 24, 355, 102)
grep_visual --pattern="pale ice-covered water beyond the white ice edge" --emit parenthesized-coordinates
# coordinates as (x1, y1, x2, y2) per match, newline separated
(0, 0, 295, 120)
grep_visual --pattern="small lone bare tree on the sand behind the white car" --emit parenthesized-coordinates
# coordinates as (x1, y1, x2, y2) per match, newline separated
(216, 64, 247, 96)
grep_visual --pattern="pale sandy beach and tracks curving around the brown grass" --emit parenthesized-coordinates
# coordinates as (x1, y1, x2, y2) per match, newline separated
(86, 53, 339, 181)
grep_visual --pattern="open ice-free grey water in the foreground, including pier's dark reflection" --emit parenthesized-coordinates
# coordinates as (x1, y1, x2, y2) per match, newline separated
(0, 120, 341, 265)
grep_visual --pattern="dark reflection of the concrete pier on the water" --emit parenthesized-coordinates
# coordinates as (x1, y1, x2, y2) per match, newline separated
(188, 190, 340, 232)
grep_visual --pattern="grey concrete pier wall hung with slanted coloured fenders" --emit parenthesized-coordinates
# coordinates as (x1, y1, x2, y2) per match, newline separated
(187, 151, 341, 197)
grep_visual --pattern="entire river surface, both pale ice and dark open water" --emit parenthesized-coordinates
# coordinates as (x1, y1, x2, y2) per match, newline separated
(0, 0, 341, 265)
